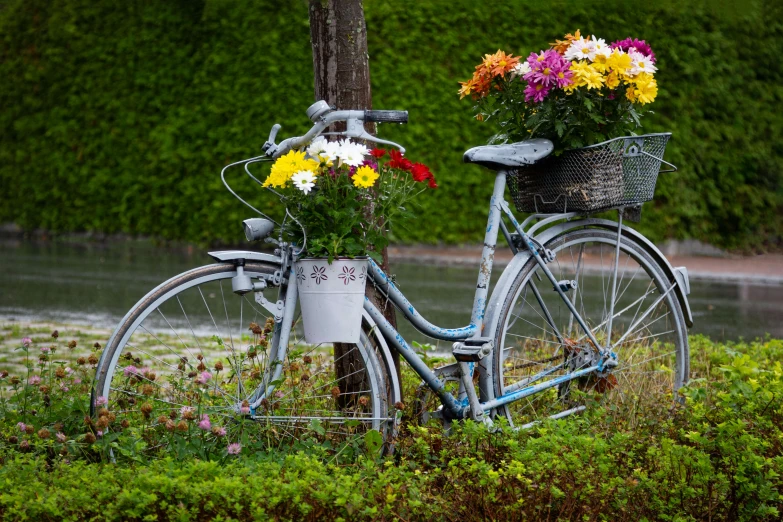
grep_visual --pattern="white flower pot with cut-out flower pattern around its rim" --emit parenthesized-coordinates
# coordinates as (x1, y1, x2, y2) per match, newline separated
(294, 258, 367, 344)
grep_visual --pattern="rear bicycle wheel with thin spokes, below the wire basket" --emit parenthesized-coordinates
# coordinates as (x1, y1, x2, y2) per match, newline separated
(493, 229, 689, 427)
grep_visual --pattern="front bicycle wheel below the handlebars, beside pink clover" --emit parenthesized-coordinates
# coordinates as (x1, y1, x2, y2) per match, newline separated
(94, 263, 392, 445)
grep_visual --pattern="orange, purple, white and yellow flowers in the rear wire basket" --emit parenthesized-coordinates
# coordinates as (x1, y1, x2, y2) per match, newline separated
(459, 30, 658, 153)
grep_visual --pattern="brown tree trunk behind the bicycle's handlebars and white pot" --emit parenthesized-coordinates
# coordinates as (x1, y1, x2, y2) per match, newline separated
(310, 0, 400, 407)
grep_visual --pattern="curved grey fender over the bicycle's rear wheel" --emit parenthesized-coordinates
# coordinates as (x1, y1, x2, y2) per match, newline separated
(482, 218, 693, 344)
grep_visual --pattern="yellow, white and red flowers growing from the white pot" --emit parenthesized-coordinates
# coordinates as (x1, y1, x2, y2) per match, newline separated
(264, 136, 438, 262)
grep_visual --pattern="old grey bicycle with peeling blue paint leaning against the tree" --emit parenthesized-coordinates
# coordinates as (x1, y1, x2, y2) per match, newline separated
(92, 102, 693, 447)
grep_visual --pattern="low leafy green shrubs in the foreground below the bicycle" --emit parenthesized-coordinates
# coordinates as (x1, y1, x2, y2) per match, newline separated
(0, 336, 783, 522)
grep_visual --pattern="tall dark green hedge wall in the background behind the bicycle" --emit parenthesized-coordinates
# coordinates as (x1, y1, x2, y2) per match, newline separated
(0, 0, 783, 248)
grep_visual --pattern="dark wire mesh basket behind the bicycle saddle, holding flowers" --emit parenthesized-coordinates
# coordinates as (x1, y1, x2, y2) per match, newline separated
(508, 132, 676, 214)
